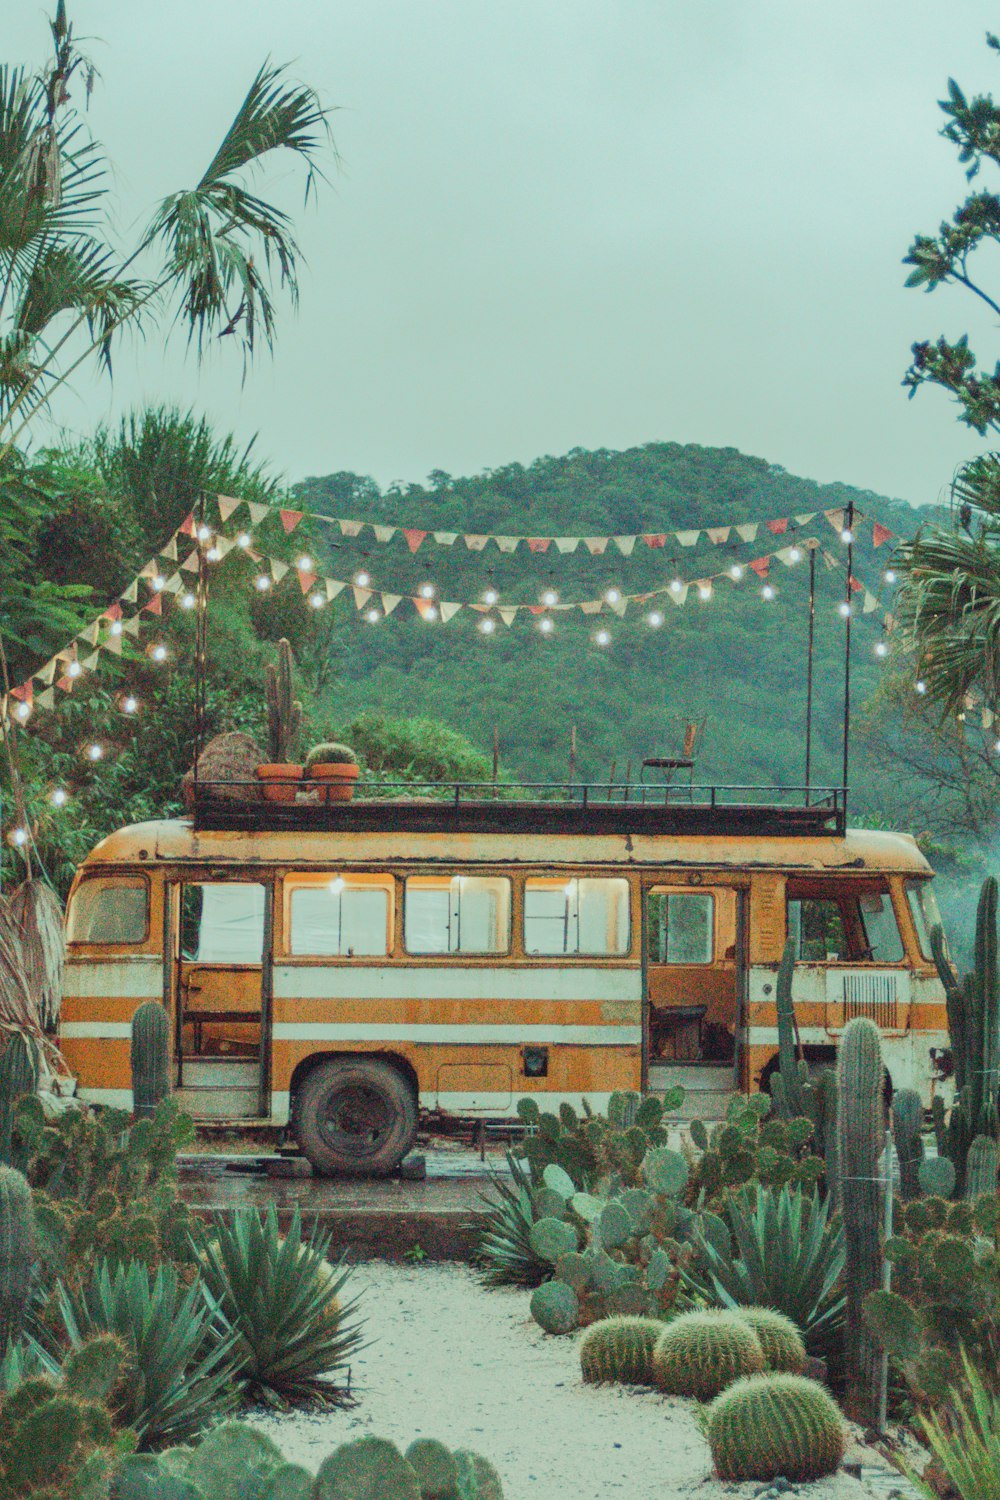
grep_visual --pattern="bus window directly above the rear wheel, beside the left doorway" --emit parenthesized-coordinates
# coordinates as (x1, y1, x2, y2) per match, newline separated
(286, 875, 391, 959)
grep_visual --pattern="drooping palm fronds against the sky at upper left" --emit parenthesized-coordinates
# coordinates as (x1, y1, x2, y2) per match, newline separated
(0, 0, 328, 453)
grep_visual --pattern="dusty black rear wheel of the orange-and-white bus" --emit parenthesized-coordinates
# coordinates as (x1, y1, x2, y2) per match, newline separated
(294, 1058, 417, 1178)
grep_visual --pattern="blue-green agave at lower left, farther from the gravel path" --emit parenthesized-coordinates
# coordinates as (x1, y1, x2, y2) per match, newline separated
(57, 1260, 241, 1449)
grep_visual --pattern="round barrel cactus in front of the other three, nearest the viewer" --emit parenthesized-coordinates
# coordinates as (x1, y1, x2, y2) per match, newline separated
(706, 1374, 846, 1484)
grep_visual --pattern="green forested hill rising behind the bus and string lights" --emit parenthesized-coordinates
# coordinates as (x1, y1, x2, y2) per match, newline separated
(297, 443, 927, 807)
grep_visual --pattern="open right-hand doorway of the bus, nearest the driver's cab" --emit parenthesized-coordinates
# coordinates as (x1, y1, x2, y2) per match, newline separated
(643, 882, 747, 1088)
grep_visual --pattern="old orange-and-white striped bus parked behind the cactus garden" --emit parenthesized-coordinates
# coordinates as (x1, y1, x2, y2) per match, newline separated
(60, 789, 949, 1173)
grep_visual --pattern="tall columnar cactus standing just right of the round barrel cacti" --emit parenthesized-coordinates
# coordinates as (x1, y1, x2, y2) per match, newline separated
(837, 1017, 885, 1424)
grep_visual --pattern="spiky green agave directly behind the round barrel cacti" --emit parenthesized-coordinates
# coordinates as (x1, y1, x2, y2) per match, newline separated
(681, 1184, 846, 1356)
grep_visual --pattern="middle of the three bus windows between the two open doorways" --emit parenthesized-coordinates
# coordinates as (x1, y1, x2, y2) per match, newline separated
(403, 875, 510, 954)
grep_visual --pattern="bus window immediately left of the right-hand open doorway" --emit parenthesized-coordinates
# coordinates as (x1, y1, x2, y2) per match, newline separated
(525, 878, 630, 954)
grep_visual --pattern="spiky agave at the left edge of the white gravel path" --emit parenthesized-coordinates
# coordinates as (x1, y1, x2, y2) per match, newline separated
(202, 1203, 361, 1404)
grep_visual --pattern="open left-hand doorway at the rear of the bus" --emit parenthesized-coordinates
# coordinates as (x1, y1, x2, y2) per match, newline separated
(171, 881, 271, 1119)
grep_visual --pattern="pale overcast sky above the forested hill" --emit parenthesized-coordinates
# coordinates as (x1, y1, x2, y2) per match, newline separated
(7, 0, 1000, 503)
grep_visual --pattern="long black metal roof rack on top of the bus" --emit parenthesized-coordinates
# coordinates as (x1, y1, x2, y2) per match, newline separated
(189, 782, 847, 837)
